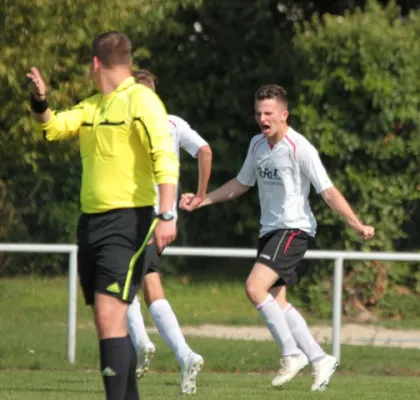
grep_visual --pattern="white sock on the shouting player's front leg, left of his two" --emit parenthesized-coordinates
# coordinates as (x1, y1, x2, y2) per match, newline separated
(257, 294, 301, 356)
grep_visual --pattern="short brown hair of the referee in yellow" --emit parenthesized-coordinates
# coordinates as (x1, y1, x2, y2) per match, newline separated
(92, 31, 131, 67)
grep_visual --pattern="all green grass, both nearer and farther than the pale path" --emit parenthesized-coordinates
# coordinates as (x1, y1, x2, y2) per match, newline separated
(0, 278, 420, 400)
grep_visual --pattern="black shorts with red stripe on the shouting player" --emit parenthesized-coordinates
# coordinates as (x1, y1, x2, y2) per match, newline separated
(257, 229, 309, 286)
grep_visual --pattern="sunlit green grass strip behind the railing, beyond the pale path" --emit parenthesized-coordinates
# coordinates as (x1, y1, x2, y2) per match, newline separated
(0, 278, 420, 329)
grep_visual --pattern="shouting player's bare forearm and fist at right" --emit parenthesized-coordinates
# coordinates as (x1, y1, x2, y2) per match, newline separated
(321, 186, 375, 240)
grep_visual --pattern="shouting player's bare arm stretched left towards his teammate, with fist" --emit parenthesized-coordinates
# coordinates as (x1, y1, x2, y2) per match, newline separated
(179, 178, 250, 211)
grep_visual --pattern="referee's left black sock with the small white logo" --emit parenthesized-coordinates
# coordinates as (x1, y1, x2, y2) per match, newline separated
(99, 336, 131, 400)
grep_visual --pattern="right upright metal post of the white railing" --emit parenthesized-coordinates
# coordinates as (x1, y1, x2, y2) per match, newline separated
(332, 257, 343, 361)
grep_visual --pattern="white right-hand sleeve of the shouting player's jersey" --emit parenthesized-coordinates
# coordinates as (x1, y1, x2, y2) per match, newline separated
(297, 142, 334, 193)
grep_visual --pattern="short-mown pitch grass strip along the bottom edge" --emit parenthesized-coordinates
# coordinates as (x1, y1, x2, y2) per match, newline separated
(0, 371, 419, 400)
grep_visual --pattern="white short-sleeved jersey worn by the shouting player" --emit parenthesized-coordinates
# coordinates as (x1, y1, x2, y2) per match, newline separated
(237, 127, 333, 237)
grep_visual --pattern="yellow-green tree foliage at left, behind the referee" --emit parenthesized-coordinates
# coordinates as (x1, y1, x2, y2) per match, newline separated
(0, 0, 200, 273)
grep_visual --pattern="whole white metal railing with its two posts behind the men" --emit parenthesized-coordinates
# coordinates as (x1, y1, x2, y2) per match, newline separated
(0, 243, 420, 363)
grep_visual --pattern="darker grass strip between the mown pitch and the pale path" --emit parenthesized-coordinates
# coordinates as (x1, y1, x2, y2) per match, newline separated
(0, 332, 420, 376)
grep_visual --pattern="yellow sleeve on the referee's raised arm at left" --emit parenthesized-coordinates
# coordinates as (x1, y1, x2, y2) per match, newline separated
(32, 102, 84, 140)
